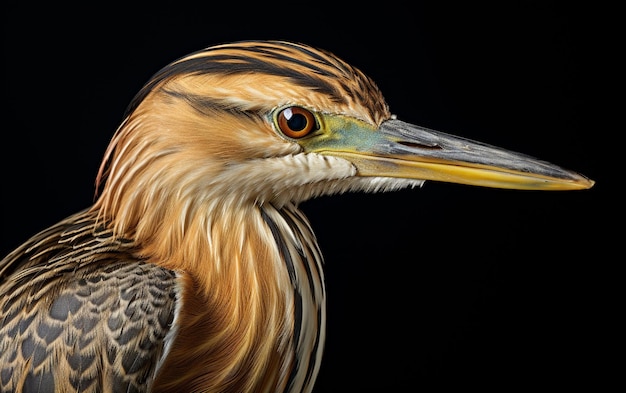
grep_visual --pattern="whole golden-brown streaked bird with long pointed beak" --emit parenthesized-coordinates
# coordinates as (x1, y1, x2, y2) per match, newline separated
(0, 40, 594, 393)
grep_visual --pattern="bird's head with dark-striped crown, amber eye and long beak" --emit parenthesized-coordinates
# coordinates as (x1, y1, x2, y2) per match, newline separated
(98, 41, 593, 236)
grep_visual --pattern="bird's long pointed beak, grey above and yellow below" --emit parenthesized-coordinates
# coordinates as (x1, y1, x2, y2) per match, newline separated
(308, 119, 594, 190)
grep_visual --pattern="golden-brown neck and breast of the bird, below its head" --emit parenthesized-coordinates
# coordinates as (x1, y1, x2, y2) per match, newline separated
(95, 189, 325, 392)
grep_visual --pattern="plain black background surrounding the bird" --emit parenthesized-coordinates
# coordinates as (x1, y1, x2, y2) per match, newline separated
(0, 2, 612, 393)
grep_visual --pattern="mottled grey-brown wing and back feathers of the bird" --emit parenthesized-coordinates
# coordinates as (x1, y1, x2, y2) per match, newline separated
(0, 212, 179, 392)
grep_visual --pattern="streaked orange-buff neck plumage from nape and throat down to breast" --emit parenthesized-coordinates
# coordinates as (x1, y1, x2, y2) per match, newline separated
(94, 108, 326, 392)
